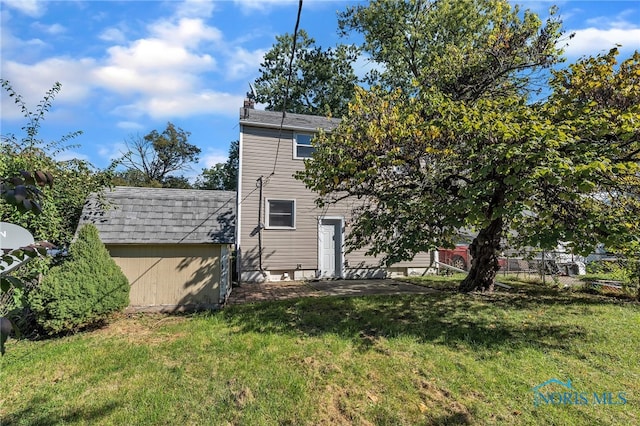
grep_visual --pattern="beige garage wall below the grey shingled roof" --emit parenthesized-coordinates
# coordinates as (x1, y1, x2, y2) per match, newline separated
(107, 244, 222, 307)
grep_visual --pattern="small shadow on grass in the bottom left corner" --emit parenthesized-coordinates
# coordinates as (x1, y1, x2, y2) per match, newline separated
(0, 397, 118, 426)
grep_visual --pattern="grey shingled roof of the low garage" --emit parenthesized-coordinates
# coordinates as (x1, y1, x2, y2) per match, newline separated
(78, 186, 236, 244)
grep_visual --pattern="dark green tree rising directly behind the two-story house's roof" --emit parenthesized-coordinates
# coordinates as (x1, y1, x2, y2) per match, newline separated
(255, 30, 358, 116)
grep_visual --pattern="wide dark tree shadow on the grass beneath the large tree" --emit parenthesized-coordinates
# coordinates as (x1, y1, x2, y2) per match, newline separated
(221, 288, 636, 351)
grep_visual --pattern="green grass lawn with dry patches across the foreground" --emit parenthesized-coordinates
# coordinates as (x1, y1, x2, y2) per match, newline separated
(0, 281, 640, 425)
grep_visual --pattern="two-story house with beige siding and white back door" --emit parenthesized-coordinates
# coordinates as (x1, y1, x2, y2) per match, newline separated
(236, 102, 433, 282)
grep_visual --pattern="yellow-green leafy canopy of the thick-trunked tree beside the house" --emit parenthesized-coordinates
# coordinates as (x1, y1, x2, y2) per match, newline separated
(297, 44, 640, 280)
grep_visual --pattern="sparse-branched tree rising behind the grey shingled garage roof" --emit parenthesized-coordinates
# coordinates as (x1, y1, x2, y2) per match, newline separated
(115, 122, 200, 187)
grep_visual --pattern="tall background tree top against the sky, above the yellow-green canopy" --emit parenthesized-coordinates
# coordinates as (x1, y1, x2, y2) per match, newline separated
(338, 0, 561, 100)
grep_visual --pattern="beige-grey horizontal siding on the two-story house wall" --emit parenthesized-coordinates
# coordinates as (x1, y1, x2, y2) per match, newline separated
(238, 110, 429, 271)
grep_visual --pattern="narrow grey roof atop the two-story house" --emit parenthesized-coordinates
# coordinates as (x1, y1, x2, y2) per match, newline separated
(240, 108, 340, 131)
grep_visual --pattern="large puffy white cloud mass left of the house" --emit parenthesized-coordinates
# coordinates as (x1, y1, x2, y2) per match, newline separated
(2, 1, 255, 125)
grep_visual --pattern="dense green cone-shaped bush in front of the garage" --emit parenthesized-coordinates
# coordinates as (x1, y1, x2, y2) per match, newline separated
(29, 225, 129, 334)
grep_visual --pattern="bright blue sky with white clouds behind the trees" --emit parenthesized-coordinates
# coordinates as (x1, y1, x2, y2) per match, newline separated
(0, 0, 640, 176)
